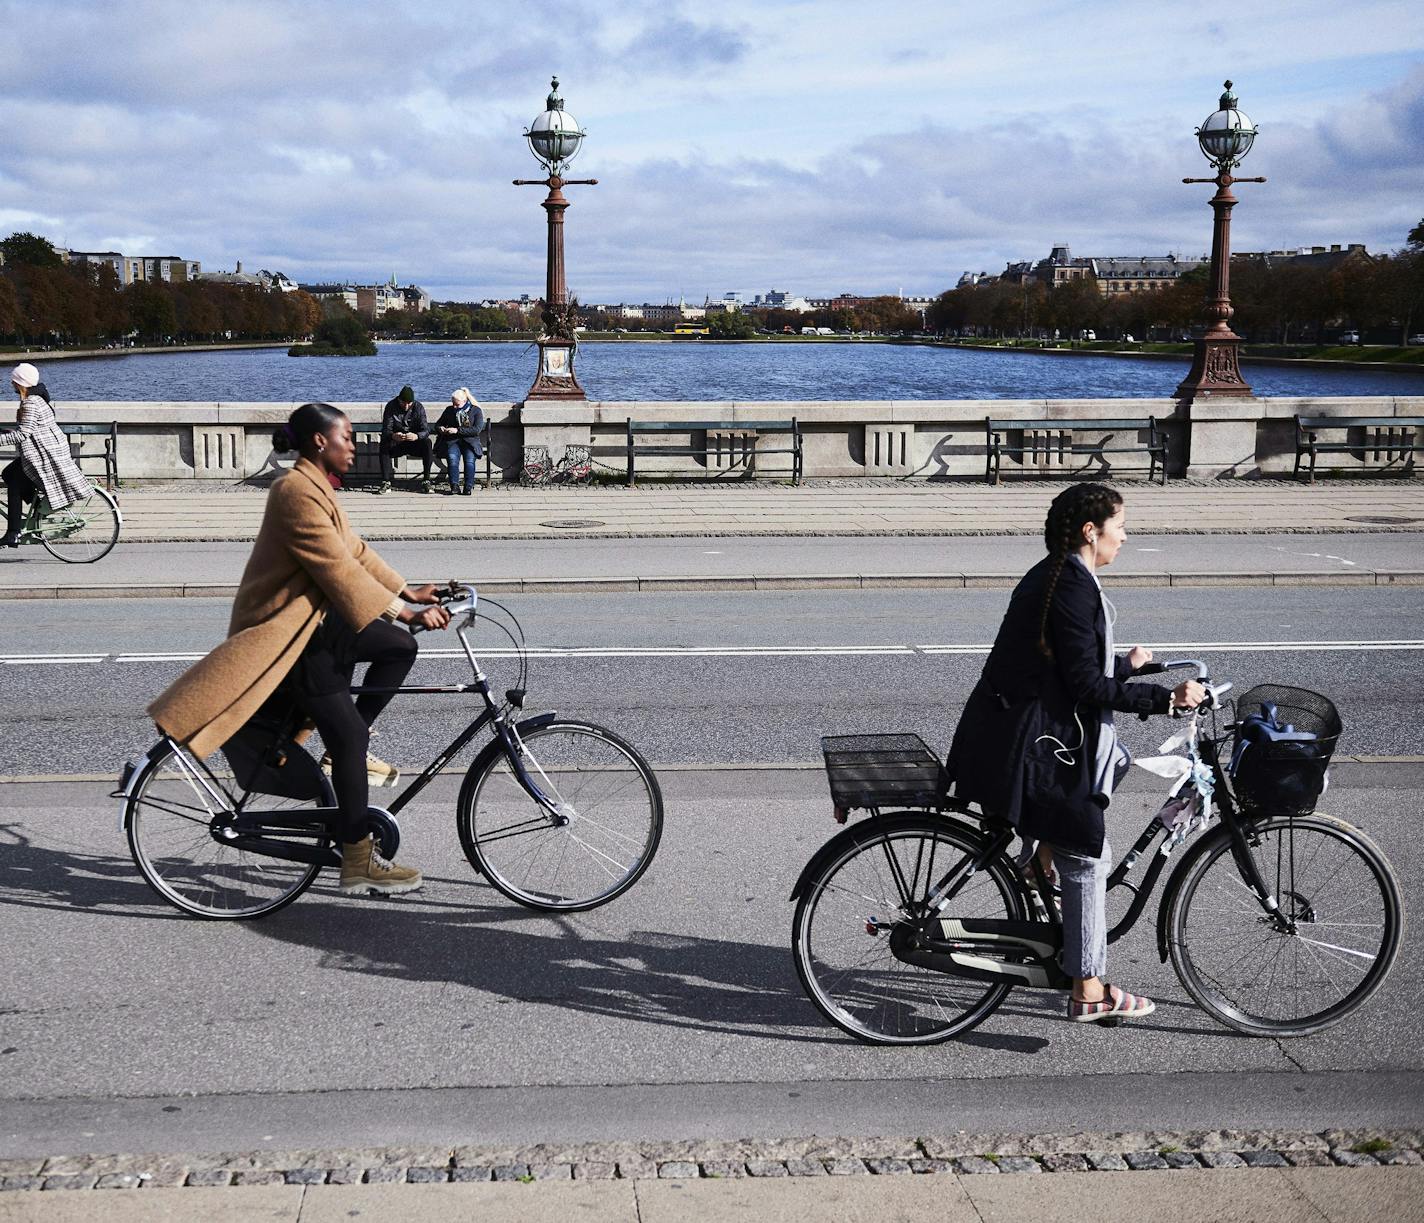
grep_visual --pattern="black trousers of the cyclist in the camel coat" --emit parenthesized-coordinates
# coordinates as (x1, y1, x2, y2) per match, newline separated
(288, 612, 419, 843)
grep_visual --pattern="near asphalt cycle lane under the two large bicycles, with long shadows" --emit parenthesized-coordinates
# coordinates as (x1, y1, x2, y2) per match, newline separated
(0, 766, 1424, 1153)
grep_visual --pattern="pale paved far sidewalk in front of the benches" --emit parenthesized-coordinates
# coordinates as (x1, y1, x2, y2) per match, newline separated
(103, 480, 1424, 542)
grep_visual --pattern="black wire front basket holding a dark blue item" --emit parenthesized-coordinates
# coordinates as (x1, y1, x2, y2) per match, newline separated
(1230, 683, 1341, 816)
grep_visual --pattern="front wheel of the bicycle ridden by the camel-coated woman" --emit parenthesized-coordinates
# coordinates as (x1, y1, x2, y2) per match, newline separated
(456, 720, 662, 913)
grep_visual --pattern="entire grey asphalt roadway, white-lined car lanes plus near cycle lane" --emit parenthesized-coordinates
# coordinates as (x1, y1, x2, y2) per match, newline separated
(0, 588, 1424, 1153)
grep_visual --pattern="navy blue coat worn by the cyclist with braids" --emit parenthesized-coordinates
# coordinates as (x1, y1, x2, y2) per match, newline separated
(948, 557, 1172, 857)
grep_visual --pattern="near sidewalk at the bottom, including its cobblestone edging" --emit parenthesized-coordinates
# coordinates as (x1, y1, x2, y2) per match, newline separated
(0, 1130, 1424, 1223)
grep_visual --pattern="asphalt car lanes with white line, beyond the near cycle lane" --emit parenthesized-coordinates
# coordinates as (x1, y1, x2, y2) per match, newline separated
(0, 587, 1424, 776)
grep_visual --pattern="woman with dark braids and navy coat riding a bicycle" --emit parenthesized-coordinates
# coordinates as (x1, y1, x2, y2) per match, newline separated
(948, 484, 1206, 1022)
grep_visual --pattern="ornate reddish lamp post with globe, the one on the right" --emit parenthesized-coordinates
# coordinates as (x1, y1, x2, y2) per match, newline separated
(1176, 81, 1266, 397)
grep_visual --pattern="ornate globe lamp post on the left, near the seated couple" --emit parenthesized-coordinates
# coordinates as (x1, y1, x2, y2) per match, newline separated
(514, 77, 598, 400)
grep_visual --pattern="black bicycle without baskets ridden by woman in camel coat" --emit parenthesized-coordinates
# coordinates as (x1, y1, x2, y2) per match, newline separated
(115, 584, 662, 920)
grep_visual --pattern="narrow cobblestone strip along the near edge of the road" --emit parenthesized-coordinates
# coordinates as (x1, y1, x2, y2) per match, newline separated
(0, 1130, 1424, 1193)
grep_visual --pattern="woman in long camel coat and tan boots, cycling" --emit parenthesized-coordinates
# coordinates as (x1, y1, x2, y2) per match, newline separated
(148, 403, 450, 894)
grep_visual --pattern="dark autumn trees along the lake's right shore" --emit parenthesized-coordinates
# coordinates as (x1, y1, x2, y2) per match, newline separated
(928, 221, 1424, 345)
